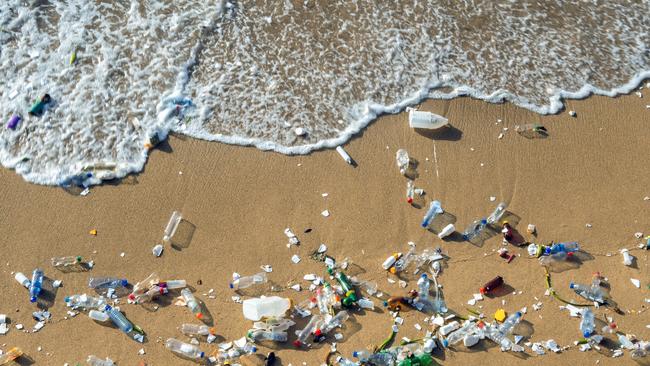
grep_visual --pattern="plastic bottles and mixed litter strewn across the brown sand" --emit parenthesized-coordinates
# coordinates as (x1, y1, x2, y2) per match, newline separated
(0, 149, 650, 366)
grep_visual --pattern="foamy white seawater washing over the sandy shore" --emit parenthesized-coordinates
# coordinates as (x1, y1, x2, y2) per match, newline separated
(0, 0, 650, 185)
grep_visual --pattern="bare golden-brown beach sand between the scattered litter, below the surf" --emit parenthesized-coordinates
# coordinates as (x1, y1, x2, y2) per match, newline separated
(0, 95, 650, 365)
